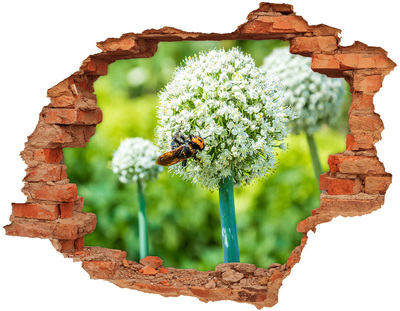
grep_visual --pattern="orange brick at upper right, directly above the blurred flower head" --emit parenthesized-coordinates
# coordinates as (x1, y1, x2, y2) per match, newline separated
(290, 36, 337, 56)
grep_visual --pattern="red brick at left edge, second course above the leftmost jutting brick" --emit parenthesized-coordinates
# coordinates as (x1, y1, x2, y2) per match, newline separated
(28, 183, 78, 202)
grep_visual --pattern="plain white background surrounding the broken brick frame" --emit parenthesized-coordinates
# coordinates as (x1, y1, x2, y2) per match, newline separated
(0, 0, 400, 311)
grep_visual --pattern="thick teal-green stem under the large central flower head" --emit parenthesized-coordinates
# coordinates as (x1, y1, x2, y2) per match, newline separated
(219, 176, 240, 263)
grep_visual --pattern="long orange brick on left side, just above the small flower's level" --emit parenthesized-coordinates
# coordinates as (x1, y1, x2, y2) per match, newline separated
(42, 108, 103, 125)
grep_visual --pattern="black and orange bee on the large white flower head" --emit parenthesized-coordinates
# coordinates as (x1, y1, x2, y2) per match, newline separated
(156, 122, 208, 167)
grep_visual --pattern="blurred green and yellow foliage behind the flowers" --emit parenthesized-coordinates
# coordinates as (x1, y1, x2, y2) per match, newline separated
(64, 40, 349, 270)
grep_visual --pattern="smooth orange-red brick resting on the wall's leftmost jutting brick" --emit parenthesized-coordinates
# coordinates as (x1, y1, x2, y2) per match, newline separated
(12, 203, 60, 220)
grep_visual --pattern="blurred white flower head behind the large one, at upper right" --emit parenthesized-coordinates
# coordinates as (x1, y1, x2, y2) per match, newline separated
(263, 47, 345, 134)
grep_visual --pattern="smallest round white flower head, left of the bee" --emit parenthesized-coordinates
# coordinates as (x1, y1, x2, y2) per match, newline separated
(111, 137, 162, 183)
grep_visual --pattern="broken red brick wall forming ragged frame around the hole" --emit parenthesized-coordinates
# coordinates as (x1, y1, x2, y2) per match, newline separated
(5, 3, 395, 308)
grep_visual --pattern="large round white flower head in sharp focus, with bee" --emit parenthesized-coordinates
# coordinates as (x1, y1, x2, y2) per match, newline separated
(156, 48, 295, 190)
